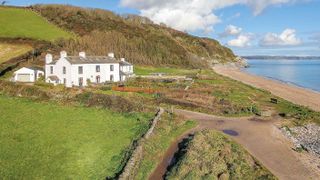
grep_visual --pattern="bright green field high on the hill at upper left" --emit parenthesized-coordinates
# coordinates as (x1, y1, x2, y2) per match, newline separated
(0, 7, 72, 41)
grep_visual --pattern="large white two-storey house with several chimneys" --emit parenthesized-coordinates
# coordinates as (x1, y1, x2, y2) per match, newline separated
(45, 51, 134, 87)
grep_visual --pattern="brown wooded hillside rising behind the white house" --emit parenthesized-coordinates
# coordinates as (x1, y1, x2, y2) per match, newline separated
(30, 5, 235, 68)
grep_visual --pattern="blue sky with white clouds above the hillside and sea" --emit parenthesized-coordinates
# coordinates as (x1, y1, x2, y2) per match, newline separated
(9, 0, 320, 56)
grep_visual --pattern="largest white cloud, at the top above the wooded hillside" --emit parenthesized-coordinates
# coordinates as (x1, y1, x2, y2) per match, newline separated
(120, 0, 305, 31)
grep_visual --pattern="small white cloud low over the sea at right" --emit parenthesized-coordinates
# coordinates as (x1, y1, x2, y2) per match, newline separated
(260, 29, 302, 46)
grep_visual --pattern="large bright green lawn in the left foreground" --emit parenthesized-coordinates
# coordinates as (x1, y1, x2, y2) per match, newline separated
(0, 95, 151, 179)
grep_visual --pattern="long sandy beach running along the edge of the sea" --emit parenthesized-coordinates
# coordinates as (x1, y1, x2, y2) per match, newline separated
(213, 66, 320, 111)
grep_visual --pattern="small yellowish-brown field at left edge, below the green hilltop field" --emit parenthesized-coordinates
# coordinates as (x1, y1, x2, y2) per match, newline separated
(0, 42, 32, 64)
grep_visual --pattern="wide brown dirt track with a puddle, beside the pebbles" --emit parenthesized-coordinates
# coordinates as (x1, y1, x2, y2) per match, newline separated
(172, 110, 320, 180)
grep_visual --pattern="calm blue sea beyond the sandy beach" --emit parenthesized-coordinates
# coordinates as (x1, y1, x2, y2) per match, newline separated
(244, 59, 320, 92)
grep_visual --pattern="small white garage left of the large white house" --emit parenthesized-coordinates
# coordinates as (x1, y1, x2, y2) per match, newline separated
(12, 67, 44, 83)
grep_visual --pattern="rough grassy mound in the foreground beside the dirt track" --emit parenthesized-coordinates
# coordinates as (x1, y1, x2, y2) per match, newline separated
(167, 131, 276, 180)
